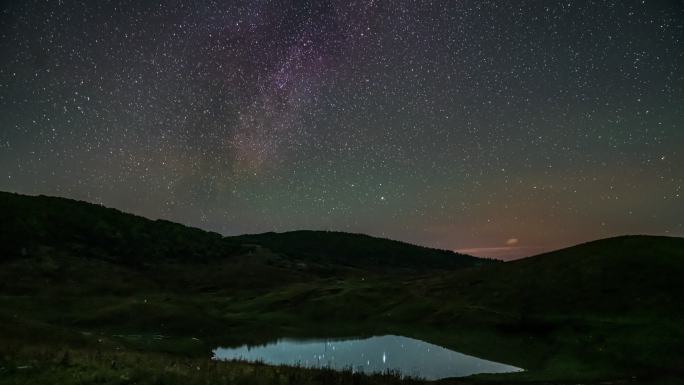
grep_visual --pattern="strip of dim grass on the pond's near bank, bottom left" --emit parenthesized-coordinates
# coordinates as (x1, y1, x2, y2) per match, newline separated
(0, 347, 421, 385)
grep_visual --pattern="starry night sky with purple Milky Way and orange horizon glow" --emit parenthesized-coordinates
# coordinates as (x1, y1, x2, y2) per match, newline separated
(0, 0, 684, 259)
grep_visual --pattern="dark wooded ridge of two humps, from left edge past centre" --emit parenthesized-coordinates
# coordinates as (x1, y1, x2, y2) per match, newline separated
(0, 192, 490, 270)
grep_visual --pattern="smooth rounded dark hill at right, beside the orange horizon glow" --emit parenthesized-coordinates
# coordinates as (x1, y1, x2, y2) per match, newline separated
(425, 235, 684, 320)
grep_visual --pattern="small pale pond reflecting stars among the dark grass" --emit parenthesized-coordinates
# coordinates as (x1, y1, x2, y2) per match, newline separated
(214, 335, 522, 380)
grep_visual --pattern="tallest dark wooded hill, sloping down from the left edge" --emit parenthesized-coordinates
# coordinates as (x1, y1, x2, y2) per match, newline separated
(0, 192, 240, 264)
